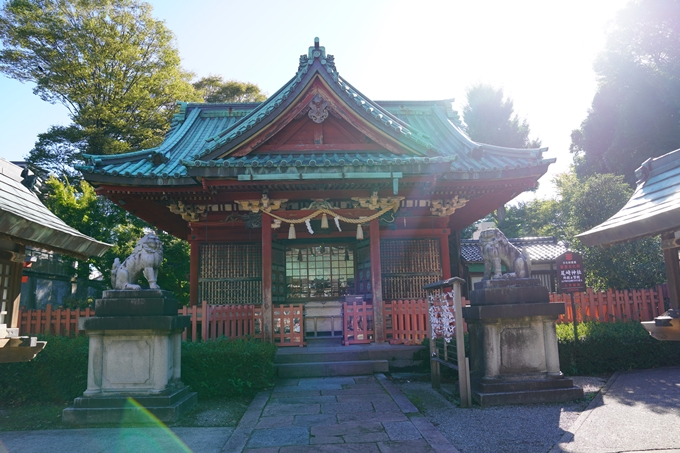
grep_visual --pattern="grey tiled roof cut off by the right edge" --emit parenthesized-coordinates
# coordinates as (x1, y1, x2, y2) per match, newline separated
(577, 149, 680, 246)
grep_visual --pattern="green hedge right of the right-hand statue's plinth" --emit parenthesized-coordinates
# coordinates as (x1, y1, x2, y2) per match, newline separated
(557, 321, 680, 375)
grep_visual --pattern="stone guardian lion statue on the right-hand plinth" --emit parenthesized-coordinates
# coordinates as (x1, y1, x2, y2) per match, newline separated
(479, 228, 531, 280)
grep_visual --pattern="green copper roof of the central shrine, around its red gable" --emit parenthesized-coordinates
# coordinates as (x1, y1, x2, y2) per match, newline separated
(78, 41, 554, 185)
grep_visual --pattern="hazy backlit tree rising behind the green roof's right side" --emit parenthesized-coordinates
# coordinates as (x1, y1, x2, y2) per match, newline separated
(463, 84, 541, 148)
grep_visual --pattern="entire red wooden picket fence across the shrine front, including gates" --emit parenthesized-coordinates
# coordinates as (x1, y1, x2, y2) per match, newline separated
(20, 285, 665, 340)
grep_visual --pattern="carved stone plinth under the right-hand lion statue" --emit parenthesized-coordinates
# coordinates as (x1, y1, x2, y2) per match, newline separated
(463, 279, 583, 406)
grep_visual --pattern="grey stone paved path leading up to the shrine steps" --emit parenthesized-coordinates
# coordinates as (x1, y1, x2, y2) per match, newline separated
(222, 374, 458, 453)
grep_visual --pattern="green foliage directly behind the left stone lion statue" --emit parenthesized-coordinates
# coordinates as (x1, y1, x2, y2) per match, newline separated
(45, 177, 189, 303)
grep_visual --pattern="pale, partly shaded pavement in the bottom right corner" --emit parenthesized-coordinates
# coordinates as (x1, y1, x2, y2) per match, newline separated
(551, 367, 680, 453)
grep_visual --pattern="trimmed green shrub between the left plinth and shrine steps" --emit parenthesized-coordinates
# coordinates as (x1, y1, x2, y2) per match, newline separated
(182, 338, 276, 398)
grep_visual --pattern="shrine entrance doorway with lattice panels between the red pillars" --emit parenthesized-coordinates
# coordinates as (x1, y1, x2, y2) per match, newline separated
(285, 240, 363, 340)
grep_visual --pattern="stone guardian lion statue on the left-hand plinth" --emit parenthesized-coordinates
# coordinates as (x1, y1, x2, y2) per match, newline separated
(111, 233, 163, 290)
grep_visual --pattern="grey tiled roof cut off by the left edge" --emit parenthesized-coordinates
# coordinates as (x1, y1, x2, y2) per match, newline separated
(0, 159, 111, 258)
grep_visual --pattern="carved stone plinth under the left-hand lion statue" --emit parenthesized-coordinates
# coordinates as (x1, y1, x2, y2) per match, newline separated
(63, 290, 197, 424)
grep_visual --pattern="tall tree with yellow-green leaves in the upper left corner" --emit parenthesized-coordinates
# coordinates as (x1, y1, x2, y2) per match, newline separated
(0, 0, 199, 166)
